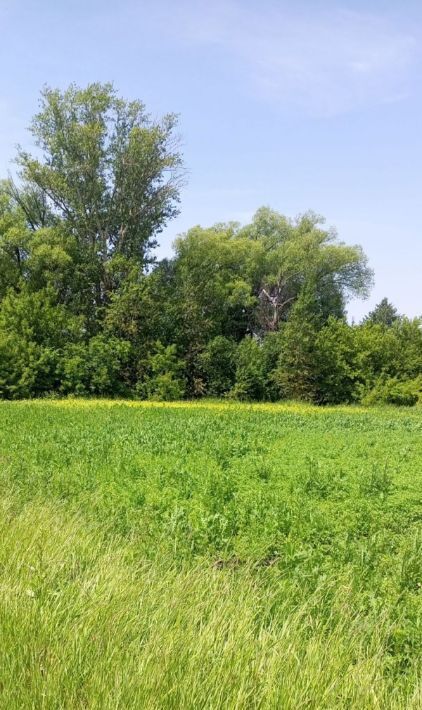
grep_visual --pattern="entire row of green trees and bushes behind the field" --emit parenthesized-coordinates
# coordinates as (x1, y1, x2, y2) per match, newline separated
(0, 84, 422, 404)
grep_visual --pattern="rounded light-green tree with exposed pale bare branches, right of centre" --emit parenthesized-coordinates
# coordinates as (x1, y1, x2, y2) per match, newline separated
(239, 207, 372, 331)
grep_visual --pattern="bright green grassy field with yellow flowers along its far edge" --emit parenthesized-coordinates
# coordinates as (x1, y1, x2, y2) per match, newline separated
(0, 400, 422, 710)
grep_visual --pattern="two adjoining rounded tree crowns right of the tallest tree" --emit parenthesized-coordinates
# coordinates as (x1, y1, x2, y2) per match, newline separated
(171, 208, 372, 350)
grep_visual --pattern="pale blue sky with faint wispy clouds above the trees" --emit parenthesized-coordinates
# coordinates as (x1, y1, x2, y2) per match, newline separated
(0, 0, 422, 319)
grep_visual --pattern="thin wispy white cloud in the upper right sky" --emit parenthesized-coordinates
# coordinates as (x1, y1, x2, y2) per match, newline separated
(161, 0, 419, 115)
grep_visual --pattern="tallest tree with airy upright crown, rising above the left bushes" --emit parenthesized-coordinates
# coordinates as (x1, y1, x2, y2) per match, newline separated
(13, 84, 182, 322)
